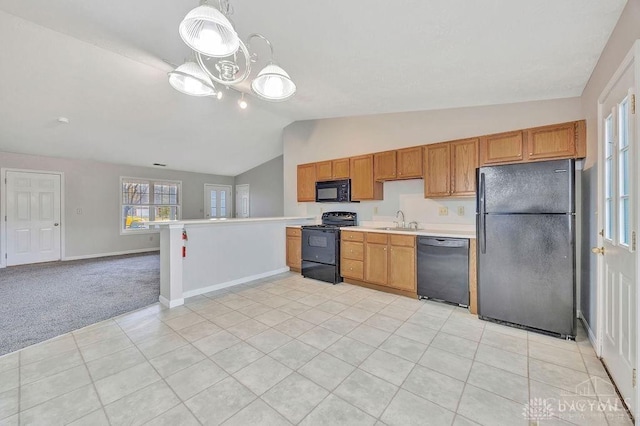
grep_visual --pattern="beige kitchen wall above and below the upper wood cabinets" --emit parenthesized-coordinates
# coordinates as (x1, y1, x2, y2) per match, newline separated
(283, 98, 582, 224)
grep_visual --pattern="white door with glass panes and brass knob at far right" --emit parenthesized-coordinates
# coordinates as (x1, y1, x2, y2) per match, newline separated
(595, 51, 640, 415)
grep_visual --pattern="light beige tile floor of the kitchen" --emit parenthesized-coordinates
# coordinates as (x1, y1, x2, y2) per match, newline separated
(0, 274, 631, 426)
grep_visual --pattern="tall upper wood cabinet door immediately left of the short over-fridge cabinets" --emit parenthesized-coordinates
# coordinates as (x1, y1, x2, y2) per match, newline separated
(451, 138, 478, 195)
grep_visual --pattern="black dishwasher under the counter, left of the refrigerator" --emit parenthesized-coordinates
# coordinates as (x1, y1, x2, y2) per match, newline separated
(418, 236, 469, 306)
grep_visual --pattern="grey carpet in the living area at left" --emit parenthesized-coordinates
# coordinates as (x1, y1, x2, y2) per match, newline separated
(0, 252, 160, 355)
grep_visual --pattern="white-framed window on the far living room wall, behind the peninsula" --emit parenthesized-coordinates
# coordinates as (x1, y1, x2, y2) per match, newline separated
(120, 177, 182, 233)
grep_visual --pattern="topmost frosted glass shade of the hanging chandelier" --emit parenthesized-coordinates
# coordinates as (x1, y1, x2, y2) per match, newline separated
(179, 4, 240, 58)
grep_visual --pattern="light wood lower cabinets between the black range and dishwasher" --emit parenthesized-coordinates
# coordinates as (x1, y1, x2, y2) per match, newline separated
(340, 231, 417, 297)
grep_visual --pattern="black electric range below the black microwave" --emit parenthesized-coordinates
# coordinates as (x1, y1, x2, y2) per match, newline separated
(302, 212, 358, 284)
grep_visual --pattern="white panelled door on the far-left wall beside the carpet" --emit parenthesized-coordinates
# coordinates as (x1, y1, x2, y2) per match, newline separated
(6, 171, 61, 266)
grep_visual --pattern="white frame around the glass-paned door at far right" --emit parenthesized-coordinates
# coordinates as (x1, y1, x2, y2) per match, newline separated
(594, 40, 640, 415)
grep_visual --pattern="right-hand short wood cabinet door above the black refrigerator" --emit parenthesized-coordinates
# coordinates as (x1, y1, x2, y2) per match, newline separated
(527, 122, 576, 160)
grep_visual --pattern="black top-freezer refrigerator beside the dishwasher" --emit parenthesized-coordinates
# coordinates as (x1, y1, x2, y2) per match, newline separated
(476, 160, 576, 338)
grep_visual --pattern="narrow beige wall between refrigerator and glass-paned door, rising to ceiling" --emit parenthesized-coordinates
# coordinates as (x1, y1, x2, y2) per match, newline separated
(579, 0, 640, 328)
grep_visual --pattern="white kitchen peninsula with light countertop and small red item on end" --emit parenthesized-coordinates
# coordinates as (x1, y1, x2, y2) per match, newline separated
(148, 217, 315, 308)
